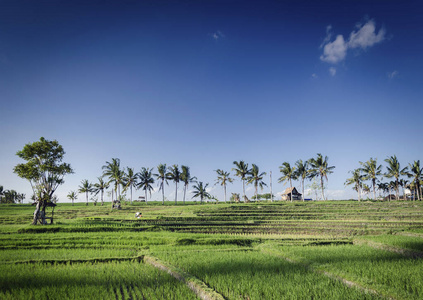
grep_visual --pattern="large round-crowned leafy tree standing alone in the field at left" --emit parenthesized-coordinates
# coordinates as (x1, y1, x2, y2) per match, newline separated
(13, 137, 73, 225)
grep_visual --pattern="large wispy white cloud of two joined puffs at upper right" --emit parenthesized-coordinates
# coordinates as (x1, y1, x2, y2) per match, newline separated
(320, 20, 385, 64)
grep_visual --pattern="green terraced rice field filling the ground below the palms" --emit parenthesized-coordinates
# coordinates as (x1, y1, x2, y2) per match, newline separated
(0, 201, 423, 299)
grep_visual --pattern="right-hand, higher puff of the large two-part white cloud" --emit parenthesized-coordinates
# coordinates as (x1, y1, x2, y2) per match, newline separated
(348, 20, 385, 49)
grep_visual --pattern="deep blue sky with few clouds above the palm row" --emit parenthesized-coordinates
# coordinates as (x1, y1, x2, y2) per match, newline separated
(0, 0, 423, 202)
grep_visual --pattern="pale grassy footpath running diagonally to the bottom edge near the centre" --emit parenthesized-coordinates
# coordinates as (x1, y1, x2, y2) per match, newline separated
(144, 256, 225, 300)
